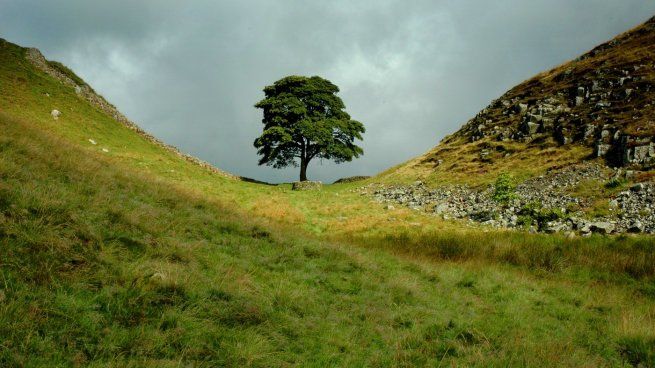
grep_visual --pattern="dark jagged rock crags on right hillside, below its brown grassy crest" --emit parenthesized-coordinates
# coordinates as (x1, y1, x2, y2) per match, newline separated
(459, 60, 655, 168)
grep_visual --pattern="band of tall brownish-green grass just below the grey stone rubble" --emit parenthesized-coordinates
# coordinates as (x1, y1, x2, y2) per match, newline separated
(341, 230, 655, 281)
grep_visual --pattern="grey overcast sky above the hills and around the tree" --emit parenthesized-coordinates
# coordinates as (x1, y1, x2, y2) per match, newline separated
(0, 0, 655, 182)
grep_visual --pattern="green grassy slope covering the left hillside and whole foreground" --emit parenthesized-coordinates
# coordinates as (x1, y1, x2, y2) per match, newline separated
(0, 38, 655, 366)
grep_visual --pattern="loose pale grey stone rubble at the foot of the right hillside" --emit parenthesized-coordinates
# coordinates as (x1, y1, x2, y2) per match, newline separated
(359, 165, 655, 235)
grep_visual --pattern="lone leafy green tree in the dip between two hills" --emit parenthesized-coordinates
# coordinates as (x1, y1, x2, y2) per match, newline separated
(255, 76, 365, 181)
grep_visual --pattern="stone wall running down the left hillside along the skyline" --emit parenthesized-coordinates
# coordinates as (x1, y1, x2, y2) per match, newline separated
(25, 48, 237, 179)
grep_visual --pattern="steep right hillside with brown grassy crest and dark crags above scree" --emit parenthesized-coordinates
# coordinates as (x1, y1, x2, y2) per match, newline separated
(442, 18, 655, 169)
